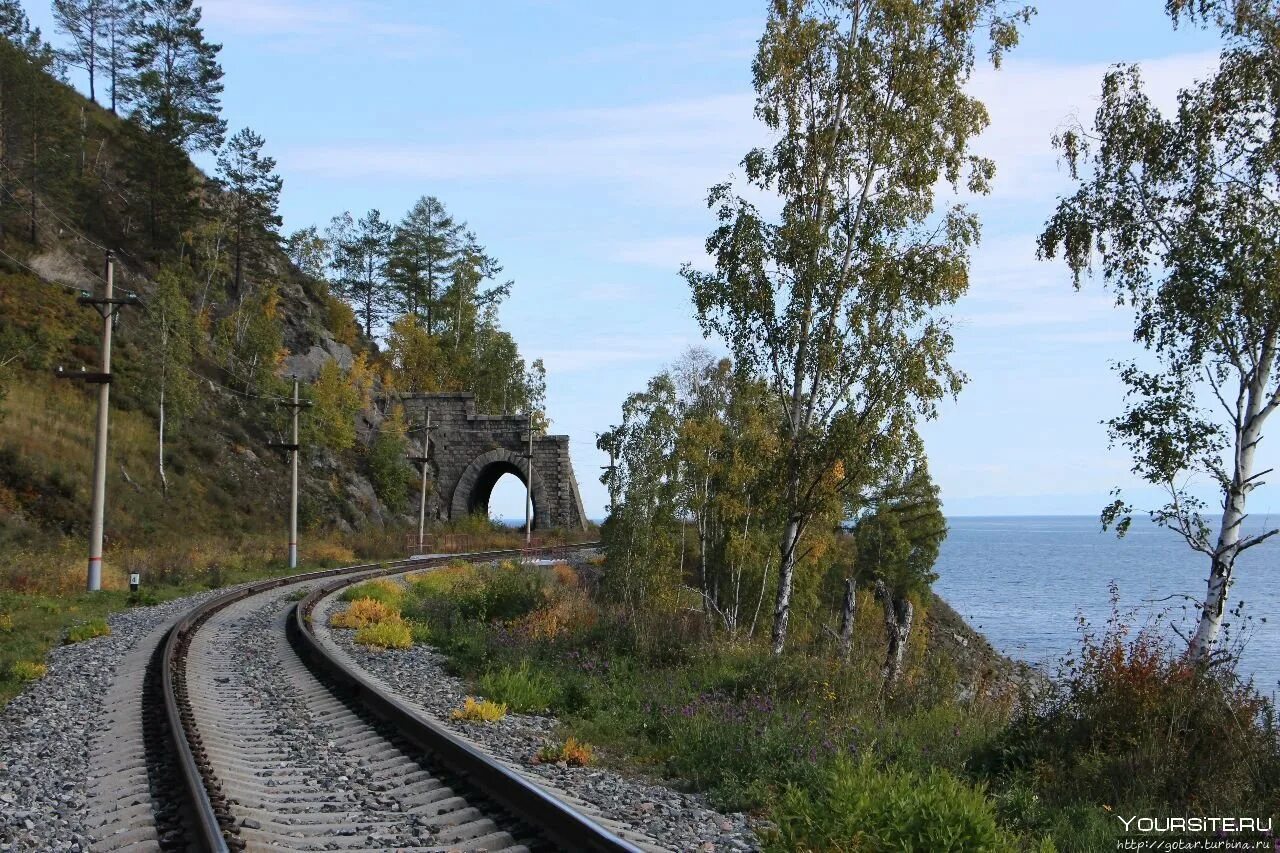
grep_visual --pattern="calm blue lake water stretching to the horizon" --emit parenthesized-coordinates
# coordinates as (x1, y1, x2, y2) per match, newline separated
(934, 516, 1280, 695)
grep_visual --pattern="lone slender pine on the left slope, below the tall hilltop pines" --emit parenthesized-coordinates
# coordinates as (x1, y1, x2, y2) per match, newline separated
(218, 128, 283, 293)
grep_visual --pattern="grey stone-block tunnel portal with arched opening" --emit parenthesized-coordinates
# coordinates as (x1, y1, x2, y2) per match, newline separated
(401, 392, 586, 529)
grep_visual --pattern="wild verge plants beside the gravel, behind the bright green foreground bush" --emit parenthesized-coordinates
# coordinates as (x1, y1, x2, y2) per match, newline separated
(404, 555, 1024, 849)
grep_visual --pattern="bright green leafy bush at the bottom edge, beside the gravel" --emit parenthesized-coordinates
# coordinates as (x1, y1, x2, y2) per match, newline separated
(765, 756, 1014, 853)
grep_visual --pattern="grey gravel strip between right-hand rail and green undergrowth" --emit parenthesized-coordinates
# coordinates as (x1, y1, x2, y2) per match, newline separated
(315, 581, 759, 852)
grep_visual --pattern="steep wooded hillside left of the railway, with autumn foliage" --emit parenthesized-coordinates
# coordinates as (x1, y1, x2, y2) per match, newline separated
(0, 3, 532, 589)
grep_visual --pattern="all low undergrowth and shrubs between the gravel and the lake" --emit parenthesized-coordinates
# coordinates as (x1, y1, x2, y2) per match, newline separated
(403, 564, 1280, 853)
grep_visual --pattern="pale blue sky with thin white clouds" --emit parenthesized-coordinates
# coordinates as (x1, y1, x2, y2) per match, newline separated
(28, 0, 1280, 517)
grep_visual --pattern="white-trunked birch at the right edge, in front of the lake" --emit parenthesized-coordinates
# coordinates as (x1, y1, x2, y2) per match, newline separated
(1039, 0, 1280, 661)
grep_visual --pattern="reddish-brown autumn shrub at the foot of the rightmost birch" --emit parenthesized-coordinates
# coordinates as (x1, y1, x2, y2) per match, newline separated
(979, 589, 1280, 813)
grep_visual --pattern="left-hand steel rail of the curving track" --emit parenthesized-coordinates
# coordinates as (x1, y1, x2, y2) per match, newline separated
(160, 542, 609, 853)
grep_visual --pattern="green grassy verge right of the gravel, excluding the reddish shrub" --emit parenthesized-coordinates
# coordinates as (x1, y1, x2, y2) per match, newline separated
(404, 558, 1116, 852)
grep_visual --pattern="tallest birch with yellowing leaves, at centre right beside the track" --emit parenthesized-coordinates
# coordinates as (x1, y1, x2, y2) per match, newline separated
(684, 0, 1032, 653)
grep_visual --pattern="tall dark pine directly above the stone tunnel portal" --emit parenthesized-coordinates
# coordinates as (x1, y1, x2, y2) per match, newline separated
(387, 196, 463, 334)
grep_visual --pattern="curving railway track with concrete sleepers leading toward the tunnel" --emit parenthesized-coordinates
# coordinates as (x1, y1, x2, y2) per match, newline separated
(92, 546, 640, 850)
